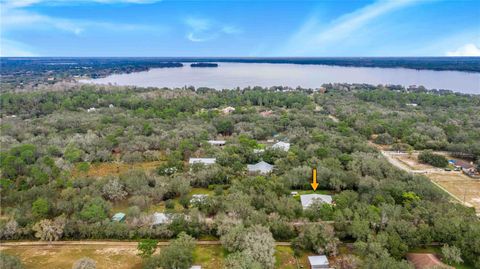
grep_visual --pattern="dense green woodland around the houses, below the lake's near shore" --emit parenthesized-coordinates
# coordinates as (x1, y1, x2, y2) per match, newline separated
(0, 84, 480, 269)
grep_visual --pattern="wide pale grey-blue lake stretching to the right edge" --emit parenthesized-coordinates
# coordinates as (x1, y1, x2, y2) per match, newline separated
(82, 63, 480, 94)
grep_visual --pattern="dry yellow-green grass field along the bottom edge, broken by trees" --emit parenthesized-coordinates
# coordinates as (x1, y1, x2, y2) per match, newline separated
(0, 241, 308, 269)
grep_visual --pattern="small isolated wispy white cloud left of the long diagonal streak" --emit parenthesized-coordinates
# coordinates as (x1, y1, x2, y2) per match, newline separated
(184, 17, 242, 42)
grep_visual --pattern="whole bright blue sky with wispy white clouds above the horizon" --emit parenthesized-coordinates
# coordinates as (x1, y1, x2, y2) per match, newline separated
(0, 0, 480, 57)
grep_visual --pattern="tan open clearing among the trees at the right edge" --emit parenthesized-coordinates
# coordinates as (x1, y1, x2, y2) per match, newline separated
(381, 150, 480, 214)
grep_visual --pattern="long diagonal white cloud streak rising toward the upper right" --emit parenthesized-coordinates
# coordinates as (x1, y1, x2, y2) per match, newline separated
(280, 0, 419, 55)
